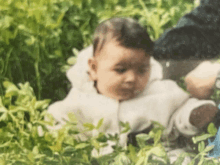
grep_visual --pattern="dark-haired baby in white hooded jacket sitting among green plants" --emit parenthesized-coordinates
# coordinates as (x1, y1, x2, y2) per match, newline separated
(48, 18, 217, 162)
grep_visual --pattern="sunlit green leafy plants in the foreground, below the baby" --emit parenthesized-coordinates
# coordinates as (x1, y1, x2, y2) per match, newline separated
(0, 81, 218, 165)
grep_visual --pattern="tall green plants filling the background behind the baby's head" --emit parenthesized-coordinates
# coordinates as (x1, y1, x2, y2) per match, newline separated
(0, 0, 195, 101)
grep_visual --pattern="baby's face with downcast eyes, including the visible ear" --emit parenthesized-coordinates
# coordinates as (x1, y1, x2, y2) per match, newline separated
(89, 41, 150, 101)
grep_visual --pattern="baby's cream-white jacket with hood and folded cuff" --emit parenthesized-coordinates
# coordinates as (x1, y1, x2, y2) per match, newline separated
(48, 46, 215, 154)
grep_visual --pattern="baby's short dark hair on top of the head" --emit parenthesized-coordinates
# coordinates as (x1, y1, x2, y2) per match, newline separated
(93, 18, 154, 55)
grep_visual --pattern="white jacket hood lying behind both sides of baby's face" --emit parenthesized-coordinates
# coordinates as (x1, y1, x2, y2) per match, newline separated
(67, 46, 163, 93)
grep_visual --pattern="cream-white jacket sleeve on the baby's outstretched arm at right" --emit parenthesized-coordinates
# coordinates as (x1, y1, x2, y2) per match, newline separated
(159, 80, 215, 139)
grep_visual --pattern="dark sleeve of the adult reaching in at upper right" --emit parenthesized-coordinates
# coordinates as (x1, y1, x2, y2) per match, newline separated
(154, 0, 220, 60)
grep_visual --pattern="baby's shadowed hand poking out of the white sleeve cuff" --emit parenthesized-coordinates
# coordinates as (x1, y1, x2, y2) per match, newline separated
(190, 104, 218, 129)
